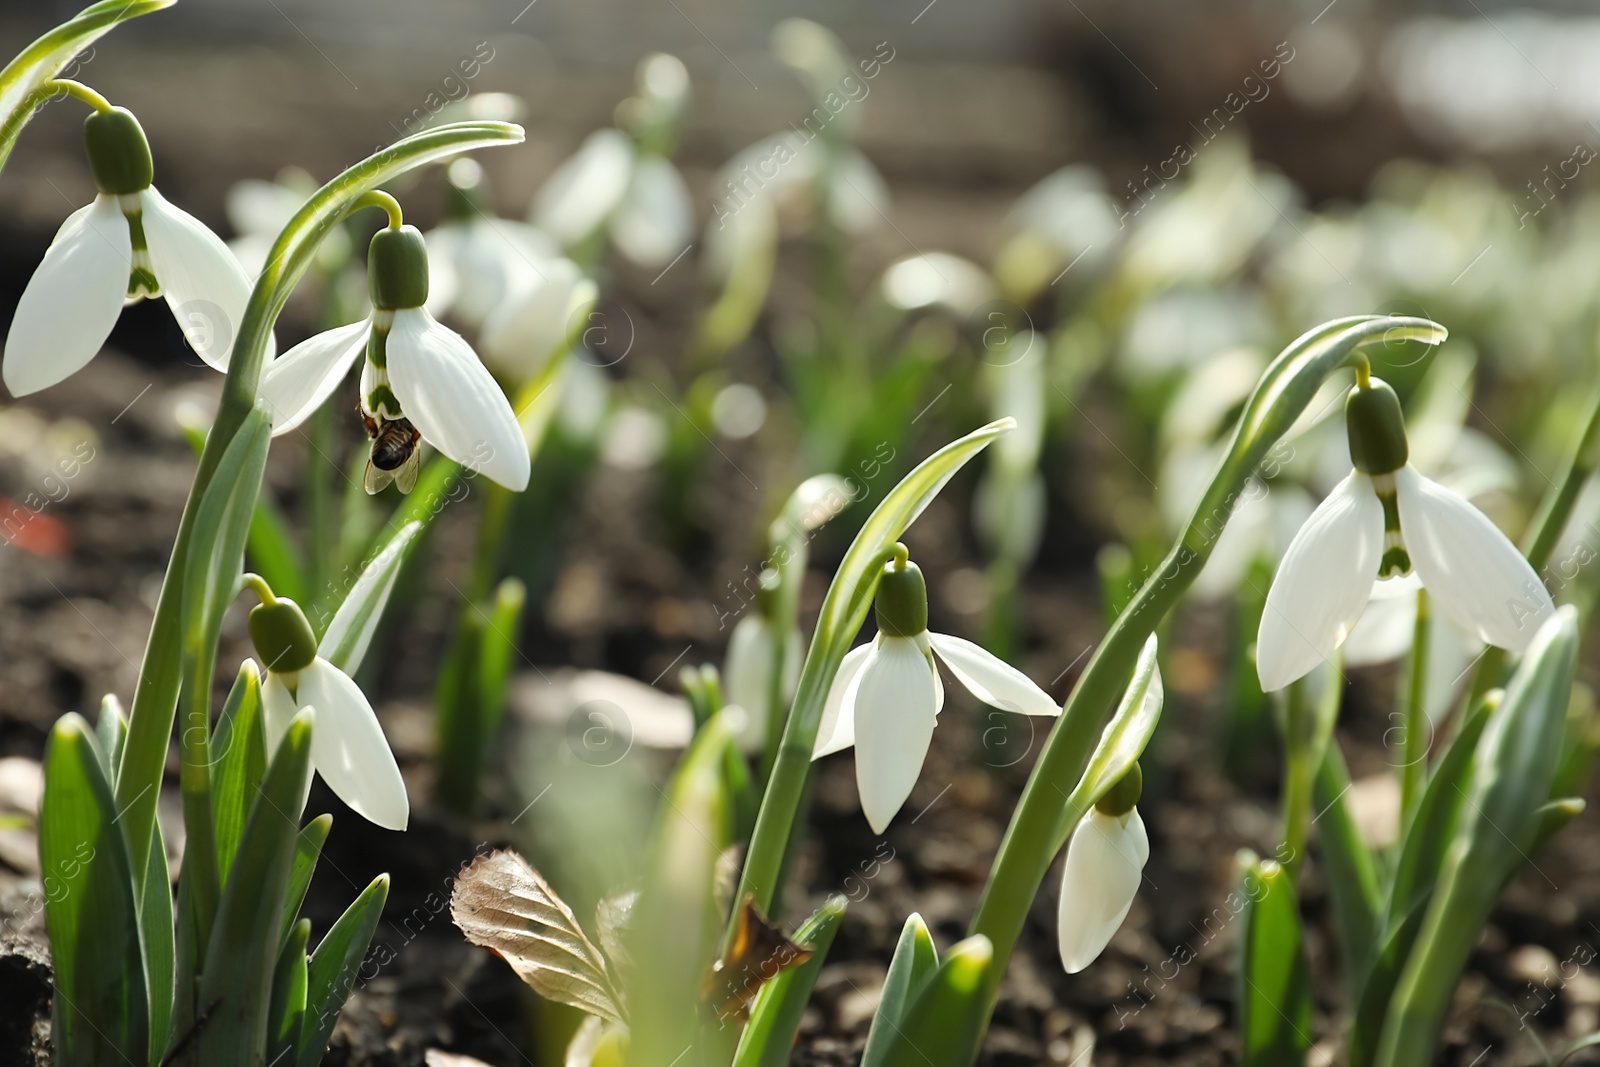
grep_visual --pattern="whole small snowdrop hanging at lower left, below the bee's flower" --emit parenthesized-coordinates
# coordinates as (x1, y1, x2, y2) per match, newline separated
(250, 582, 411, 830)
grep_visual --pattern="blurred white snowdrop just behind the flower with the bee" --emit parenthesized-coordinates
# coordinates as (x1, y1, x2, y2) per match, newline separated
(426, 158, 560, 326)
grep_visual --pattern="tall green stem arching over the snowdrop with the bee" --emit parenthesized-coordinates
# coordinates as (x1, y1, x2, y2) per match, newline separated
(117, 122, 522, 891)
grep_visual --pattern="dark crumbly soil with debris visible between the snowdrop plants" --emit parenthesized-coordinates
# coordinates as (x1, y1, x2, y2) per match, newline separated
(0, 335, 1600, 1067)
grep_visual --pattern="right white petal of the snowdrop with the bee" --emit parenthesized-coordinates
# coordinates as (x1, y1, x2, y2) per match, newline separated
(387, 307, 530, 491)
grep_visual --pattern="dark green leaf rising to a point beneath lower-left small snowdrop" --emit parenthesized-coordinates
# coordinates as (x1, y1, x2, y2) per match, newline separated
(195, 710, 312, 1064)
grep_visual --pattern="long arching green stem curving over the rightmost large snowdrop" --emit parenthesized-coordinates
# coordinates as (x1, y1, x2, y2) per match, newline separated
(970, 317, 1445, 1036)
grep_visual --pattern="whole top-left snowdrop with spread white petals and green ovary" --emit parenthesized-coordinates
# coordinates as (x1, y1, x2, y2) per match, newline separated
(3, 101, 250, 397)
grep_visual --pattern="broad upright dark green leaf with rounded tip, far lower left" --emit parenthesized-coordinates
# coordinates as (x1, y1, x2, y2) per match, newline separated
(38, 713, 150, 1067)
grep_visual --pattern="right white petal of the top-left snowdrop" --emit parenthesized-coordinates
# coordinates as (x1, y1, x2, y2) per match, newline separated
(139, 186, 262, 371)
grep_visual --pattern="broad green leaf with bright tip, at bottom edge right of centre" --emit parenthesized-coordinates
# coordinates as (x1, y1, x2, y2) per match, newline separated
(882, 934, 995, 1067)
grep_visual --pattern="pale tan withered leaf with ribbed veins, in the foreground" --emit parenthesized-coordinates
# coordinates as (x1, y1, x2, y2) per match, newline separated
(450, 849, 622, 1022)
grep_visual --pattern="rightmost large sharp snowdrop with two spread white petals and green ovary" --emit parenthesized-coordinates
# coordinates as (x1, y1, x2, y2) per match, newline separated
(1256, 374, 1555, 693)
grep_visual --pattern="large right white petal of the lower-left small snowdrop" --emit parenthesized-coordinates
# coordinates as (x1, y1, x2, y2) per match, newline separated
(298, 657, 411, 830)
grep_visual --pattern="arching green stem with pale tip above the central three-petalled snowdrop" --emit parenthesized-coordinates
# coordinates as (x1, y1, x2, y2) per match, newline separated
(738, 419, 1016, 912)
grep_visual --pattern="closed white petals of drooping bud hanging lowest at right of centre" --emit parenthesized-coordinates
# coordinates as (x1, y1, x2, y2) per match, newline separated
(1056, 808, 1150, 974)
